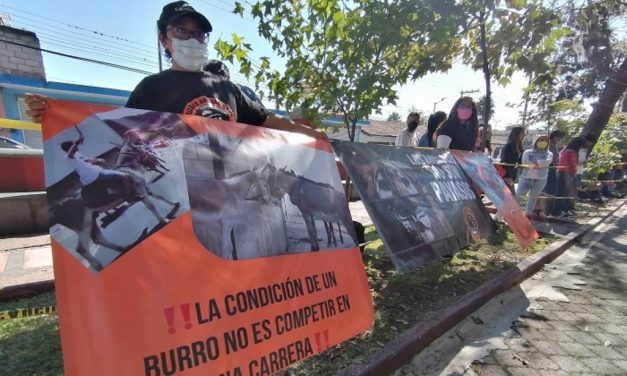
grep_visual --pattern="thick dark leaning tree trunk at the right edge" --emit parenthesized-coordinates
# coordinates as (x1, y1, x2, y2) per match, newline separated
(581, 58, 627, 145)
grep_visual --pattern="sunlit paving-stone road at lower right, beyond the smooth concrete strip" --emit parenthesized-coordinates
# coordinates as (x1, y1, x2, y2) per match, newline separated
(464, 209, 627, 376)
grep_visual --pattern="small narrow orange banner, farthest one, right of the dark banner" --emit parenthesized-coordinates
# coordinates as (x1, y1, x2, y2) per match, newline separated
(452, 150, 538, 248)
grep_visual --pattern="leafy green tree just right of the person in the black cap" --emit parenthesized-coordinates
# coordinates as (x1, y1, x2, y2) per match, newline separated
(218, 0, 463, 140)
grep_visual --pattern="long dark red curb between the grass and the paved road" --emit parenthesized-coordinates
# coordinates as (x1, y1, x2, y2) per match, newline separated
(338, 200, 627, 376)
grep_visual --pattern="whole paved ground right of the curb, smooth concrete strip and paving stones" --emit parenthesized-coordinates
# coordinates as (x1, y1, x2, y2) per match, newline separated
(396, 207, 627, 376)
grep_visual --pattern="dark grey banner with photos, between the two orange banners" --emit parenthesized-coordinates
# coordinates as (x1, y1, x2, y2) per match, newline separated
(332, 141, 495, 270)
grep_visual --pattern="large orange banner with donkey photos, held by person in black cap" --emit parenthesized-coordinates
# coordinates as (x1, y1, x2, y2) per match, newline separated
(43, 100, 374, 376)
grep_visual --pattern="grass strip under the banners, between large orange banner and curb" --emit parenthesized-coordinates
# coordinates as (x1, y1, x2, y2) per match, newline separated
(286, 226, 556, 375)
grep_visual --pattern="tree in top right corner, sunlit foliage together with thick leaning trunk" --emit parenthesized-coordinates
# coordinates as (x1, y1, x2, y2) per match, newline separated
(527, 0, 627, 147)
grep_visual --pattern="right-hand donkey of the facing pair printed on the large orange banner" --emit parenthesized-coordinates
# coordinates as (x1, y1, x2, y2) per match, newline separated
(270, 167, 356, 252)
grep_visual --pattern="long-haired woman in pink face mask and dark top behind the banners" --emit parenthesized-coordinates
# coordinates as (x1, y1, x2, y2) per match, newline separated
(436, 97, 479, 151)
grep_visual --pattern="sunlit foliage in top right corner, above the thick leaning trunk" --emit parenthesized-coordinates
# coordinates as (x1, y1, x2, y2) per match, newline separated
(526, 0, 627, 121)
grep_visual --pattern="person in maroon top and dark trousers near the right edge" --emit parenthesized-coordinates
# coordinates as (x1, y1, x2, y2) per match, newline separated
(556, 137, 585, 217)
